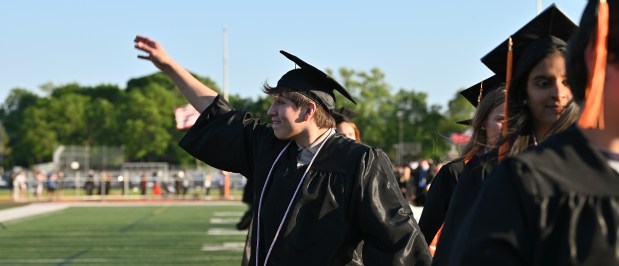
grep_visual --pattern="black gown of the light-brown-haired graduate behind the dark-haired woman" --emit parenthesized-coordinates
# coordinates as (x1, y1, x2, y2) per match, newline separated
(419, 158, 464, 245)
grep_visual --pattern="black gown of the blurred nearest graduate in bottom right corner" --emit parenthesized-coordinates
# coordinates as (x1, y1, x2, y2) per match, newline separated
(452, 126, 619, 266)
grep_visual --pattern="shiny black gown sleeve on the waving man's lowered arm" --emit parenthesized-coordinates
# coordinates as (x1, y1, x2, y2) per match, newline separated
(354, 149, 432, 265)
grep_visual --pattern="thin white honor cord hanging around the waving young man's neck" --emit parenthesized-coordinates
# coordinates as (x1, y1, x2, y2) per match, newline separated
(255, 129, 333, 266)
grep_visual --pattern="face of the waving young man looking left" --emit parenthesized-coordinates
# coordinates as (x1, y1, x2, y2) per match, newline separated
(267, 94, 304, 139)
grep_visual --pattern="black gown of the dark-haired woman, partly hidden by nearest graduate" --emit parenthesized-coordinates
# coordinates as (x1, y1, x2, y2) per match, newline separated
(433, 152, 497, 265)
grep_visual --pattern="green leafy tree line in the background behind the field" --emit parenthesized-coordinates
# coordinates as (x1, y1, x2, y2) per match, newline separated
(0, 68, 474, 169)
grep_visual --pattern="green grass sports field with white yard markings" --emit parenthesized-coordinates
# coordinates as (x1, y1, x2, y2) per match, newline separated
(0, 204, 246, 265)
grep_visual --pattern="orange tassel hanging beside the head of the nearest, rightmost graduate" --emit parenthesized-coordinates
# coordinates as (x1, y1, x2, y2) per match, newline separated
(578, 0, 609, 129)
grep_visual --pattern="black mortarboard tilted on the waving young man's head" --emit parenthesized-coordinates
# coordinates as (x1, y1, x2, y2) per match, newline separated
(277, 51, 357, 112)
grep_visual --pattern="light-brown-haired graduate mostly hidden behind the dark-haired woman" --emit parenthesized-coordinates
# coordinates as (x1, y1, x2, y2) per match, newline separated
(419, 75, 505, 254)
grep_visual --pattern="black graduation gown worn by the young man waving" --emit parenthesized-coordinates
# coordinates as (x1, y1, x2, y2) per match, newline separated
(180, 97, 431, 265)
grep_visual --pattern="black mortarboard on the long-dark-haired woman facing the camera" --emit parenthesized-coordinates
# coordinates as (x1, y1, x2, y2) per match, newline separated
(481, 4, 578, 78)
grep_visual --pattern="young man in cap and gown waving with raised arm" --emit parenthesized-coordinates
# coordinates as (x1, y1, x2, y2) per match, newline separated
(135, 36, 432, 265)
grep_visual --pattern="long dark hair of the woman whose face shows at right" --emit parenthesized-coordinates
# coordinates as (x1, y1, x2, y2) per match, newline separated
(499, 36, 580, 156)
